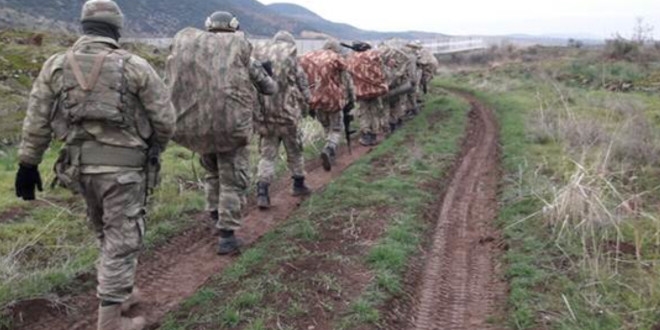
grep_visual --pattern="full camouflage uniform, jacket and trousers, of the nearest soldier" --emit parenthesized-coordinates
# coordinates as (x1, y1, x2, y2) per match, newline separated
(19, 36, 175, 302)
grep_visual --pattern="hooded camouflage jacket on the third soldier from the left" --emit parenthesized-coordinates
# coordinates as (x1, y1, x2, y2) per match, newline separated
(253, 31, 311, 129)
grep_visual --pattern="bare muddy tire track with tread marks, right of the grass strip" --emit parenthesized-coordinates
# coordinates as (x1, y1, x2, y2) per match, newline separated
(408, 93, 506, 330)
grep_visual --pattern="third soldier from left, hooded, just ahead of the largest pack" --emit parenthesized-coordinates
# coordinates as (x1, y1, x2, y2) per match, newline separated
(255, 31, 311, 209)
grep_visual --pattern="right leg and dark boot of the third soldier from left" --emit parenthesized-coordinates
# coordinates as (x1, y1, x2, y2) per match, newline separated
(282, 126, 311, 196)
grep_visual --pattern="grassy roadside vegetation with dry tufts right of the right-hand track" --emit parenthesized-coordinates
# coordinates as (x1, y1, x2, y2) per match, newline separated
(443, 39, 660, 330)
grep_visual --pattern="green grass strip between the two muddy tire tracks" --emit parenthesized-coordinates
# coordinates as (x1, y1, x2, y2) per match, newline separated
(163, 86, 469, 330)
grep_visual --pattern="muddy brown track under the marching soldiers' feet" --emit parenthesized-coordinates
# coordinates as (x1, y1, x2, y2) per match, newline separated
(13, 143, 372, 330)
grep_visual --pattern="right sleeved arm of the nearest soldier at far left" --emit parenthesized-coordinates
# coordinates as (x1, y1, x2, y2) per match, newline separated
(129, 56, 176, 149)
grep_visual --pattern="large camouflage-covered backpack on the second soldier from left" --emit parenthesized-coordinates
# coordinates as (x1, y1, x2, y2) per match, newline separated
(167, 28, 257, 154)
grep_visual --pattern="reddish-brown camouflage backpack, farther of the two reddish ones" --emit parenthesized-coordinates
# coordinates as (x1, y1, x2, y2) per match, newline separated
(347, 50, 389, 101)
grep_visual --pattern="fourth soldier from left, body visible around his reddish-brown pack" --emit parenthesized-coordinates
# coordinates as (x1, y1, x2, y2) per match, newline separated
(313, 39, 355, 171)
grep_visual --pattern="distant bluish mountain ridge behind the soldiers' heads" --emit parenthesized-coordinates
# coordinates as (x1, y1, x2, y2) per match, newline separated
(0, 0, 442, 40)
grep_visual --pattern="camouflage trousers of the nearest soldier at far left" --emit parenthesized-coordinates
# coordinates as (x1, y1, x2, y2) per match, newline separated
(80, 171, 146, 303)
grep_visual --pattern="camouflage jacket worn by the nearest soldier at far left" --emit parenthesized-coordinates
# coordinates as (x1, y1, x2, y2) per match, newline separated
(19, 35, 175, 173)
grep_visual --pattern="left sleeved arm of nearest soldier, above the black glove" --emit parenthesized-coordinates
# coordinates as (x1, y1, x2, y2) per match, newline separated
(18, 55, 62, 165)
